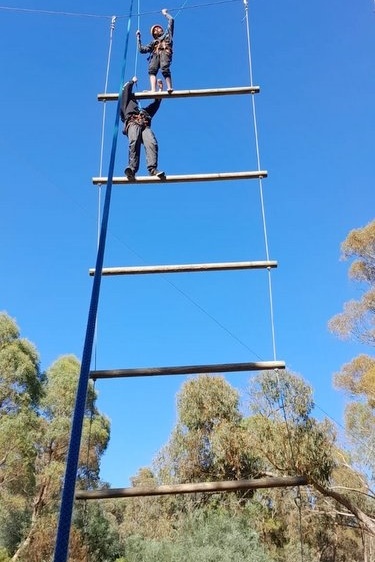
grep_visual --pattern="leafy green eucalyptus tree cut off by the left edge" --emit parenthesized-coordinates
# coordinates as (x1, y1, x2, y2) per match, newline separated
(0, 312, 43, 550)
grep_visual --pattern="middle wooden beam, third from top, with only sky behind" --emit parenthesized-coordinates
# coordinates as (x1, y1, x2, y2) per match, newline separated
(89, 261, 277, 276)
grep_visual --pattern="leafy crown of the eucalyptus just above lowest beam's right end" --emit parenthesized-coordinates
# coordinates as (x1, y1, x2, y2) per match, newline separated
(247, 371, 335, 482)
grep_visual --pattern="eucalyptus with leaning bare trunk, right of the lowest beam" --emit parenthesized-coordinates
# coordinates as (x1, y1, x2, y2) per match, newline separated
(248, 372, 375, 536)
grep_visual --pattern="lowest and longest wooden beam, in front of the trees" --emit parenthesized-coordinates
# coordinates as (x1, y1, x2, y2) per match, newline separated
(76, 476, 308, 500)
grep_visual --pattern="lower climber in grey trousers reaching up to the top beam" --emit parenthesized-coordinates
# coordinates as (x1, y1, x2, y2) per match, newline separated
(120, 76, 165, 181)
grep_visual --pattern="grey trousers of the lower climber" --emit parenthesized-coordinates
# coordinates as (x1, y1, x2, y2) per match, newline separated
(127, 123, 158, 173)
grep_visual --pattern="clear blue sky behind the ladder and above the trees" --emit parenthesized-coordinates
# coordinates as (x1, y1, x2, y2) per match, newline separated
(0, 0, 375, 487)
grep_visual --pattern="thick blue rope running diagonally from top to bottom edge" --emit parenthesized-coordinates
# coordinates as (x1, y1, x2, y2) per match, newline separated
(53, 4, 133, 562)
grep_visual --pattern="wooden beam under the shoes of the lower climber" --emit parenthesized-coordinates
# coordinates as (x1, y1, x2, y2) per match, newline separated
(92, 170, 267, 185)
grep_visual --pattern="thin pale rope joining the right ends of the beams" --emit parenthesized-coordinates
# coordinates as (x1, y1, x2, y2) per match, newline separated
(243, 0, 276, 360)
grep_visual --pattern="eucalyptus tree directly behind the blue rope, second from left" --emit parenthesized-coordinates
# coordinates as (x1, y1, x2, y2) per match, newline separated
(12, 355, 110, 562)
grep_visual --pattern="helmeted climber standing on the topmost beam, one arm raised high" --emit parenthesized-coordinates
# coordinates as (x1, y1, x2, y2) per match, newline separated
(136, 8, 174, 94)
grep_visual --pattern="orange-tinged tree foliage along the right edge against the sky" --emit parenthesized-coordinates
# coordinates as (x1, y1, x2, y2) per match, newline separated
(329, 220, 375, 479)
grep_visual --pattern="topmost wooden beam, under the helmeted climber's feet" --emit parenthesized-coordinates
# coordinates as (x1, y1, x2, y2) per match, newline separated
(98, 86, 260, 101)
